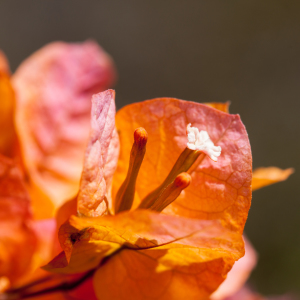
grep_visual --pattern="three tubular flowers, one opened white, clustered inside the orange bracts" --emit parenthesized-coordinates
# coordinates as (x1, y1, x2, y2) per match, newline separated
(115, 124, 221, 213)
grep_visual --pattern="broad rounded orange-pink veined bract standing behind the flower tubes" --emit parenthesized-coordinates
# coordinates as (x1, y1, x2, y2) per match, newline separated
(113, 98, 252, 233)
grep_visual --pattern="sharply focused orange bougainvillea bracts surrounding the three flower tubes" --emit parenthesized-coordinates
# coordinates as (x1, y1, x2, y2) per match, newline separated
(40, 91, 252, 299)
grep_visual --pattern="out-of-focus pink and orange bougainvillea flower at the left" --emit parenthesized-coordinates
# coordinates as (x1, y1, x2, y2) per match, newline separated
(0, 42, 115, 291)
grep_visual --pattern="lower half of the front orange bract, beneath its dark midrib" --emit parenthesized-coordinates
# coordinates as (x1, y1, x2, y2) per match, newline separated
(94, 226, 243, 300)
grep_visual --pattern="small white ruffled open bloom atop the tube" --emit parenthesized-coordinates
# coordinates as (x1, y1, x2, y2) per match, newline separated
(186, 124, 222, 161)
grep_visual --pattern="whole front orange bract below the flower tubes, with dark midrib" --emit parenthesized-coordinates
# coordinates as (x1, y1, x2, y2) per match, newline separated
(45, 210, 244, 299)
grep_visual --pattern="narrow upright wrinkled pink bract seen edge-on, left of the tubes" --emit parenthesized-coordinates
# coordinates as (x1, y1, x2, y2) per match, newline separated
(77, 90, 119, 217)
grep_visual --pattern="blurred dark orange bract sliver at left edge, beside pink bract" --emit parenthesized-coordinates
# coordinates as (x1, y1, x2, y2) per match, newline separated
(0, 52, 16, 157)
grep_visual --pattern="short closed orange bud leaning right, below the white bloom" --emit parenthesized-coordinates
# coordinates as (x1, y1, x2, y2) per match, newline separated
(147, 173, 191, 212)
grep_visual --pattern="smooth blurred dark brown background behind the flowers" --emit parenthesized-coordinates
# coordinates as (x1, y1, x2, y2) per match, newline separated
(0, 0, 300, 295)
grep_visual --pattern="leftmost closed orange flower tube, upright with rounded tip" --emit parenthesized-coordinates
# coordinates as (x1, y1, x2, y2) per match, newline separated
(115, 127, 148, 213)
